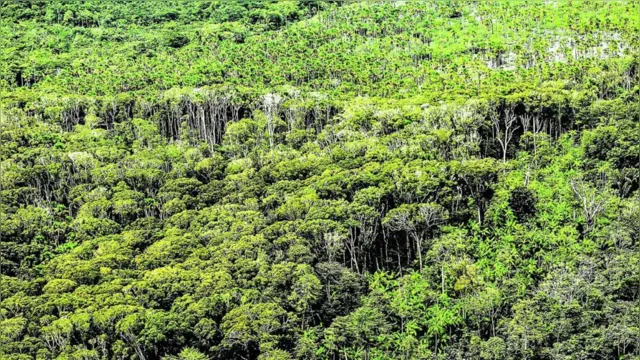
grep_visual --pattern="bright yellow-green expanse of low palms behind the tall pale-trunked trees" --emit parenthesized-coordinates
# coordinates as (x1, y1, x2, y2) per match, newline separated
(0, 0, 640, 97)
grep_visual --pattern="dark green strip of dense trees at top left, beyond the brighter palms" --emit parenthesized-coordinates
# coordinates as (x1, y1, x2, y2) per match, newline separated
(0, 0, 331, 29)
